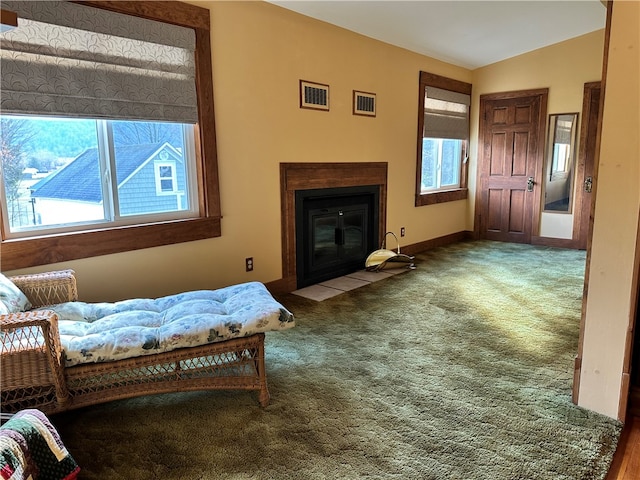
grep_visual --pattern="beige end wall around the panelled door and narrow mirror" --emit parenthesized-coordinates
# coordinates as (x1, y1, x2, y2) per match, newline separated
(468, 29, 604, 238)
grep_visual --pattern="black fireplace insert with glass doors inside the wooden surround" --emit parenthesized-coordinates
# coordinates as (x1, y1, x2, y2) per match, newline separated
(295, 185, 380, 288)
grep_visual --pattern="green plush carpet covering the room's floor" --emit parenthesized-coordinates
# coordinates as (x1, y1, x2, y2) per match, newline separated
(52, 241, 621, 480)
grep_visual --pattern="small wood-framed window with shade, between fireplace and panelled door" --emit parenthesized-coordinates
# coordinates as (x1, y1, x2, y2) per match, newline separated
(416, 72, 471, 206)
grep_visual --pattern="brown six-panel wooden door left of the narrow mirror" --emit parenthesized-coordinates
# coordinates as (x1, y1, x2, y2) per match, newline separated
(476, 89, 548, 243)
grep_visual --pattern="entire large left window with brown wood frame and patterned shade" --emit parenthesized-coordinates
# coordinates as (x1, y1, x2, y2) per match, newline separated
(0, 0, 220, 270)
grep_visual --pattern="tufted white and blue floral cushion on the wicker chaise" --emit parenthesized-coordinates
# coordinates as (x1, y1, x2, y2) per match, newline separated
(37, 282, 295, 366)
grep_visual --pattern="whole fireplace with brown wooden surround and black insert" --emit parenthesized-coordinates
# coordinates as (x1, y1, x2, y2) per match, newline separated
(276, 162, 387, 292)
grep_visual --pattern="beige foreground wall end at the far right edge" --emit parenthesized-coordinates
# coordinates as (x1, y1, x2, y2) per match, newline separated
(579, 1, 640, 417)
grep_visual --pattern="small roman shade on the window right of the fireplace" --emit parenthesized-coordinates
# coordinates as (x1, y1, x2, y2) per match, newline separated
(423, 86, 471, 140)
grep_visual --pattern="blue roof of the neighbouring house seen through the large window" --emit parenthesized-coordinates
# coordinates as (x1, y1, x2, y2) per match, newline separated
(31, 142, 177, 203)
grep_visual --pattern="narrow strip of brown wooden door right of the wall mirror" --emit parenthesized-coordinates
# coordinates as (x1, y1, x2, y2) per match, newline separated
(573, 82, 601, 250)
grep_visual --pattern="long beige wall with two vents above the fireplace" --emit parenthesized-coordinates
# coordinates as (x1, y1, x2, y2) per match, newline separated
(5, 1, 471, 301)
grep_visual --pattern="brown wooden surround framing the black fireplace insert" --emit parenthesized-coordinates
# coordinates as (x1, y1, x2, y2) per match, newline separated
(278, 162, 388, 291)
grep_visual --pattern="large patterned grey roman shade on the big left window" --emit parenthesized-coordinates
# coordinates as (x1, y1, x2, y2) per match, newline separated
(0, 0, 198, 123)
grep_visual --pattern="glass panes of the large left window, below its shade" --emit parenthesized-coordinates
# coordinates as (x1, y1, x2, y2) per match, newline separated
(0, 115, 198, 233)
